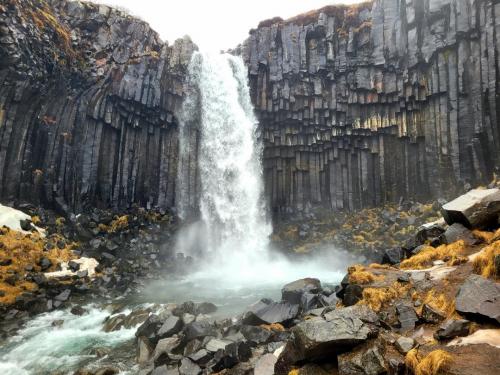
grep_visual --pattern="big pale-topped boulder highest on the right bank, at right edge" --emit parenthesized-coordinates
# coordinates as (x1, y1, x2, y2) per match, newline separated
(442, 188, 500, 228)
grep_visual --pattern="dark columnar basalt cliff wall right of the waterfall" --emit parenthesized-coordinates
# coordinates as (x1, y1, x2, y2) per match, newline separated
(239, 0, 500, 210)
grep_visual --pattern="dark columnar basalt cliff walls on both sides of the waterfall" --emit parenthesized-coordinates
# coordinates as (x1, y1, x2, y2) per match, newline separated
(0, 0, 500, 216)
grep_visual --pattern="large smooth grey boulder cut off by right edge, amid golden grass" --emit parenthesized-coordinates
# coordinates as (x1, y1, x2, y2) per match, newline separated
(455, 275, 500, 323)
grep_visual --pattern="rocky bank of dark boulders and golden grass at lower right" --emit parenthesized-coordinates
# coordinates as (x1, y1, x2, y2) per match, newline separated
(121, 189, 500, 375)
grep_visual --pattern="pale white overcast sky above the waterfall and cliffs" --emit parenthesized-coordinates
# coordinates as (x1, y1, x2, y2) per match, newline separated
(92, 0, 360, 50)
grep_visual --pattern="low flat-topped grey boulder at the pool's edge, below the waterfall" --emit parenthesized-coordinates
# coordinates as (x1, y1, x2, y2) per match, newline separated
(243, 299, 299, 325)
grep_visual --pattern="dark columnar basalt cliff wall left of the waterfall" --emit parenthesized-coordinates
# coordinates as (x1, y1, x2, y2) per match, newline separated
(0, 0, 195, 211)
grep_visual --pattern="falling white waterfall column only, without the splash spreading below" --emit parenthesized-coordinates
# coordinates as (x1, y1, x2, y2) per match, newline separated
(177, 52, 271, 267)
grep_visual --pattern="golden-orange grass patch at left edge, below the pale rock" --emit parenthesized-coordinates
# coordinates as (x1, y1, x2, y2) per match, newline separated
(0, 228, 74, 304)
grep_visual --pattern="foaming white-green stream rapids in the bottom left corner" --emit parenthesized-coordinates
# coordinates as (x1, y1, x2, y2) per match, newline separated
(0, 306, 136, 375)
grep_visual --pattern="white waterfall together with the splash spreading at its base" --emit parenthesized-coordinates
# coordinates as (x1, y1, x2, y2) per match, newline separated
(174, 53, 342, 290)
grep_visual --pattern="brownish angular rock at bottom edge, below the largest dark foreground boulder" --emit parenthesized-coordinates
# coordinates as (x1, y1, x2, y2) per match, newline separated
(337, 345, 387, 375)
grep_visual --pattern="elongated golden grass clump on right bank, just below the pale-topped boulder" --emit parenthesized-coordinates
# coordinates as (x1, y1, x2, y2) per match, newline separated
(400, 240, 467, 269)
